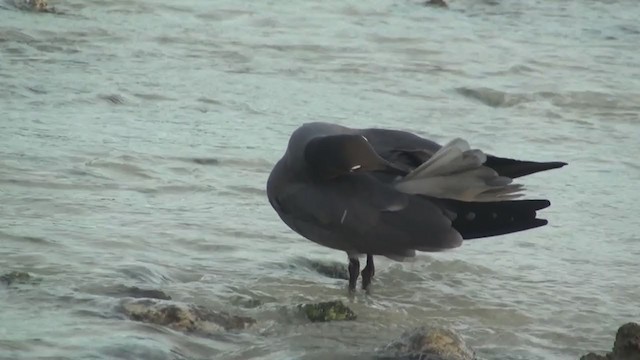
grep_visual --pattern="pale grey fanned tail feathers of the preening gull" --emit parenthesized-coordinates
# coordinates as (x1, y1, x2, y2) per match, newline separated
(395, 138, 524, 201)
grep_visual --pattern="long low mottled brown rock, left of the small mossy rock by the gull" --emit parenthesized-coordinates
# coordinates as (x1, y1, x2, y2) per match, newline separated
(121, 299, 256, 333)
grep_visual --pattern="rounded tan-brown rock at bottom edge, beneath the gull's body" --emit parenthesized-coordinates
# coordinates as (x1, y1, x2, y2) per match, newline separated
(378, 326, 476, 360)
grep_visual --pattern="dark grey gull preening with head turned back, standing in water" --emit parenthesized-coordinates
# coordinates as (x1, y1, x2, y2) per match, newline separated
(267, 122, 567, 291)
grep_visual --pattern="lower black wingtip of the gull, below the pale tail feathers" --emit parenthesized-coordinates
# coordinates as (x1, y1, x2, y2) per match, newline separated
(437, 199, 551, 240)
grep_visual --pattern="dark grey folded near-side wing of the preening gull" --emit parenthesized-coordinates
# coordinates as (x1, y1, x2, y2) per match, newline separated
(276, 173, 462, 258)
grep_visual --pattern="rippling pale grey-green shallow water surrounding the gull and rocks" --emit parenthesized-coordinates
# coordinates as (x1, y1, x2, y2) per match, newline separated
(0, 0, 640, 360)
